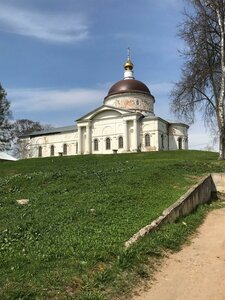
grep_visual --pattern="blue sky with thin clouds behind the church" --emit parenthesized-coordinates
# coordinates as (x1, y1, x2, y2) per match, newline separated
(0, 0, 216, 149)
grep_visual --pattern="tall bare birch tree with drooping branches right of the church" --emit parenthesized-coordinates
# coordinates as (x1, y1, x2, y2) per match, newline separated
(171, 0, 225, 159)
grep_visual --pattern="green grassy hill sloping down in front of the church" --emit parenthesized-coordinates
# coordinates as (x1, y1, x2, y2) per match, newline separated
(0, 151, 225, 300)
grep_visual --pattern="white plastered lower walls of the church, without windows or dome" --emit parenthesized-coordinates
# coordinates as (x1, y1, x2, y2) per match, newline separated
(19, 109, 188, 157)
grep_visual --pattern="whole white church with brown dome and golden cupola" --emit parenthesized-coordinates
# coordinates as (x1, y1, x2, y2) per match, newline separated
(21, 54, 189, 158)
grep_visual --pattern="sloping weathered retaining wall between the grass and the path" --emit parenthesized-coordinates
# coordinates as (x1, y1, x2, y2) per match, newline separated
(124, 173, 225, 248)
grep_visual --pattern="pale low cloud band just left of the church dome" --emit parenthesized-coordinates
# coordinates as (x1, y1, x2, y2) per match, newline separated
(7, 89, 105, 113)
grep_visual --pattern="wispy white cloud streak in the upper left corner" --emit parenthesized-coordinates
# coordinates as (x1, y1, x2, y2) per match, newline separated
(0, 3, 88, 43)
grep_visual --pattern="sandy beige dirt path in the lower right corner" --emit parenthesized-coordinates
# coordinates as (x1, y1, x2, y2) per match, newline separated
(133, 208, 225, 300)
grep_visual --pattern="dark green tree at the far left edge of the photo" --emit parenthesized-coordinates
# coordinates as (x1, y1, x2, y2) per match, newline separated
(0, 84, 12, 151)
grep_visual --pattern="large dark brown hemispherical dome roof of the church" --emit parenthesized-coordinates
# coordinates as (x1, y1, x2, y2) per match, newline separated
(107, 79, 151, 96)
